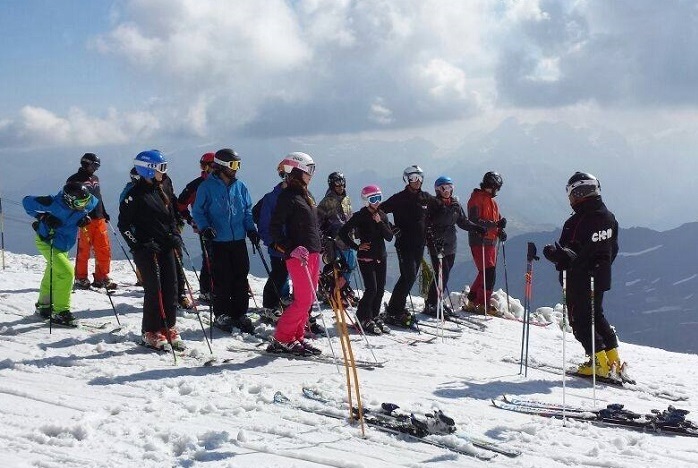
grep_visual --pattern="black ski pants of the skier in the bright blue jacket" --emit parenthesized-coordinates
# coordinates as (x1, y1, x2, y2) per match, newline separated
(210, 239, 250, 319)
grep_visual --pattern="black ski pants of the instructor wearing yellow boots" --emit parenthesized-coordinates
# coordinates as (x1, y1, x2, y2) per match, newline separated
(567, 283, 618, 356)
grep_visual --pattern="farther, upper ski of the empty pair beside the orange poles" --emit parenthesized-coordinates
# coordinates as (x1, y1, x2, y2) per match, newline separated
(303, 387, 521, 458)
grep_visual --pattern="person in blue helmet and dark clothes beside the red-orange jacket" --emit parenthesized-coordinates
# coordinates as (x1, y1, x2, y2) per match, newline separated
(424, 176, 487, 317)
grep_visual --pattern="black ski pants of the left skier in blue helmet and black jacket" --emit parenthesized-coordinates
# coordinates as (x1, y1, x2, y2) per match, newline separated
(133, 249, 177, 332)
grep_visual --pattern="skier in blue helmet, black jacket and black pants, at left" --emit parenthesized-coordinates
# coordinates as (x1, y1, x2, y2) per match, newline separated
(118, 150, 184, 350)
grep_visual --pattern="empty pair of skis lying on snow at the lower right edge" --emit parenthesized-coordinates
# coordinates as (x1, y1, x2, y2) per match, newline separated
(492, 395, 698, 437)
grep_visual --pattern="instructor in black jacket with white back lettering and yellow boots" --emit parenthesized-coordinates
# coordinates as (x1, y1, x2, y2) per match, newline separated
(543, 172, 624, 377)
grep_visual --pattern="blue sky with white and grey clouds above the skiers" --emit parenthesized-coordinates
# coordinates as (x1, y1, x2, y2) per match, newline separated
(0, 0, 698, 245)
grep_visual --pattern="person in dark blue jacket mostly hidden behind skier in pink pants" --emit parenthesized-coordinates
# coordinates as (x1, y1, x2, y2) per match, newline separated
(252, 159, 292, 324)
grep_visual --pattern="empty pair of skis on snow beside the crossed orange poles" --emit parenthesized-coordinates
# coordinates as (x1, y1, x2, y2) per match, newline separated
(274, 387, 521, 460)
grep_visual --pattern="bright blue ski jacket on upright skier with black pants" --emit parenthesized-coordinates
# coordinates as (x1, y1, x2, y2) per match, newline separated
(191, 174, 256, 242)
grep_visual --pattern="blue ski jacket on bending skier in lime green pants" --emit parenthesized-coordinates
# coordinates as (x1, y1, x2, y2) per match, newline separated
(22, 190, 99, 252)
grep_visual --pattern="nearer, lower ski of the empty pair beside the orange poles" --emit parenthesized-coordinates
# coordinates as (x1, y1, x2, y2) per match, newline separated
(274, 392, 496, 461)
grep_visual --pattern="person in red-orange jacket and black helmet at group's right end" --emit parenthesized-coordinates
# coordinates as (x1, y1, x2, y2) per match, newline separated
(465, 171, 507, 314)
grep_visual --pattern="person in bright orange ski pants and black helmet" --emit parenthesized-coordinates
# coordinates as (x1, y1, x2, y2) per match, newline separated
(67, 153, 117, 290)
